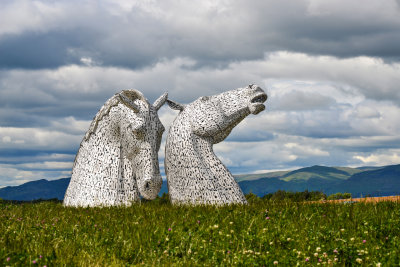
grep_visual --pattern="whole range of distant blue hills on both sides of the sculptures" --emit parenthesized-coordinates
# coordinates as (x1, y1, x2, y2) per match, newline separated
(0, 165, 400, 201)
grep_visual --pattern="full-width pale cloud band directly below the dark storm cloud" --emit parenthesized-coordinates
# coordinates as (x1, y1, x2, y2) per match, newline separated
(0, 52, 400, 126)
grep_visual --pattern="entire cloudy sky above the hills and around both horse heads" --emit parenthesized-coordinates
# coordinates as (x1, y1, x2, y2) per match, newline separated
(0, 0, 400, 187)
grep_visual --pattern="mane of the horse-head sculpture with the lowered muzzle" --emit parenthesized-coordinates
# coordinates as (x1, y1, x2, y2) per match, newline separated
(82, 89, 149, 142)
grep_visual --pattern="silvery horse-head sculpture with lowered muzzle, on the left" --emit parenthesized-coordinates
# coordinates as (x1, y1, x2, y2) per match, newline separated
(64, 90, 167, 207)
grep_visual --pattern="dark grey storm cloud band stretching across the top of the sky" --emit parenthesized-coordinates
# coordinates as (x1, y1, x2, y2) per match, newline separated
(0, 0, 400, 69)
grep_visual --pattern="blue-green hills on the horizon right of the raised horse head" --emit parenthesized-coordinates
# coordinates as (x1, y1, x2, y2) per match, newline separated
(239, 165, 400, 197)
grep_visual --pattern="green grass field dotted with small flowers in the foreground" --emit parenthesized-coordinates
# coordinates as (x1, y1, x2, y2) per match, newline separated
(0, 200, 400, 266)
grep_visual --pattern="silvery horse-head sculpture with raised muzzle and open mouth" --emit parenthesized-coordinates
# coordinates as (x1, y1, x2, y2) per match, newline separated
(165, 84, 267, 205)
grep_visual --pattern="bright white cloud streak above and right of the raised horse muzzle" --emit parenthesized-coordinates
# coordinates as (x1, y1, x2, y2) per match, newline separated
(256, 52, 400, 104)
